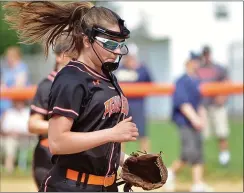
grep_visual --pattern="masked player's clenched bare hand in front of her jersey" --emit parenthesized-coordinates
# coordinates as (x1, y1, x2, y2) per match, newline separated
(111, 117, 139, 142)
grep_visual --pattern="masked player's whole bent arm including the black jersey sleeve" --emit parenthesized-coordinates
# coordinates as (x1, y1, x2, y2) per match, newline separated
(48, 73, 138, 155)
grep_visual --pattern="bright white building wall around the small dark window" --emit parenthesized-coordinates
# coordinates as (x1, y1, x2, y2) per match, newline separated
(116, 1, 243, 67)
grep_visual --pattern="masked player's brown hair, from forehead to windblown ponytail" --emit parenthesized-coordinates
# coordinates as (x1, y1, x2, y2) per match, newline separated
(4, 1, 122, 56)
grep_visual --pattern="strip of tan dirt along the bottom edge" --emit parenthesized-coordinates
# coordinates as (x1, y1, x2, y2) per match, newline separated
(0, 178, 243, 192)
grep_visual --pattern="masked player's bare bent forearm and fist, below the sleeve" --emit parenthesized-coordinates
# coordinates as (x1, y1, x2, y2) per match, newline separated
(48, 115, 136, 155)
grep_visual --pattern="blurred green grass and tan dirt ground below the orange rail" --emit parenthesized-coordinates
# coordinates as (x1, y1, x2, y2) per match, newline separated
(0, 117, 243, 192)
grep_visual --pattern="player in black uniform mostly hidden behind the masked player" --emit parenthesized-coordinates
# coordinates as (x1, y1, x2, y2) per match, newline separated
(29, 35, 74, 189)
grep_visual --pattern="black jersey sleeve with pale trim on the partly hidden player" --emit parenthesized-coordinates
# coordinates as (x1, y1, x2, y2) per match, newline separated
(30, 81, 52, 115)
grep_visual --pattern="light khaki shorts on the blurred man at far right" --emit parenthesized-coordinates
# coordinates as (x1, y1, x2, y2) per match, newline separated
(203, 105, 229, 139)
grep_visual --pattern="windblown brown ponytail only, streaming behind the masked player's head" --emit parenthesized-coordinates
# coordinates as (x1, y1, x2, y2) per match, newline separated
(4, 1, 93, 56)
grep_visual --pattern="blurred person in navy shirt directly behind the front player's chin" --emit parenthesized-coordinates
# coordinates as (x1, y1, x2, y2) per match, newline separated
(115, 44, 151, 152)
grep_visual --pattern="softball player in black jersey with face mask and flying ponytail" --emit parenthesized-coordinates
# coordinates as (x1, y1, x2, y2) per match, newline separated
(5, 1, 139, 192)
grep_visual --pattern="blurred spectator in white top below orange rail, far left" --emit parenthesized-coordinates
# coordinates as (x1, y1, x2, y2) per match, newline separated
(1, 100, 29, 173)
